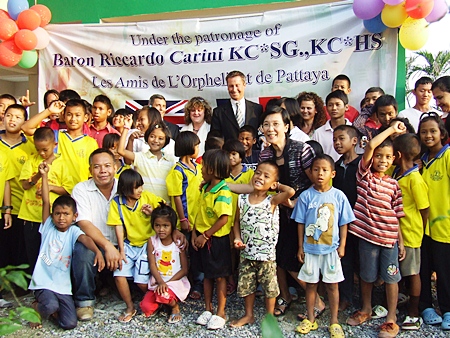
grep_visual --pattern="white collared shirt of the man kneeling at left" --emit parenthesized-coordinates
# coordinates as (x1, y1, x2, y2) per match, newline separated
(72, 179, 117, 245)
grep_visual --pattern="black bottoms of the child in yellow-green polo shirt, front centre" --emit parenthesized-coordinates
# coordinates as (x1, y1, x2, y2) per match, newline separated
(191, 231, 232, 279)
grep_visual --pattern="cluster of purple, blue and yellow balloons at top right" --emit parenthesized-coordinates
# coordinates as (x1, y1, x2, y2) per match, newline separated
(353, 0, 448, 50)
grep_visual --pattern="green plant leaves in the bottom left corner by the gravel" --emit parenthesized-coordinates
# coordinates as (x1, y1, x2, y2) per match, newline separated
(0, 264, 41, 336)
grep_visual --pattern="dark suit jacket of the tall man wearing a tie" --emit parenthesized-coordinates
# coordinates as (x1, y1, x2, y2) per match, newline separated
(211, 100, 263, 141)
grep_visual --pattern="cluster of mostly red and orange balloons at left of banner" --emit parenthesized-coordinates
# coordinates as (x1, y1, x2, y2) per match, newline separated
(0, 0, 52, 68)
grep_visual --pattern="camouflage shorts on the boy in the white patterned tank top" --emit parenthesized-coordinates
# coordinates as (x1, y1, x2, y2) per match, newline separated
(237, 257, 280, 298)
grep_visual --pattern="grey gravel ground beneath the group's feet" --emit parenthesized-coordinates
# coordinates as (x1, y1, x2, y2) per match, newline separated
(0, 282, 450, 338)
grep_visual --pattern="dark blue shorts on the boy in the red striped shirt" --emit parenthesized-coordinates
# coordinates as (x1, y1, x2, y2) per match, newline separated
(359, 239, 401, 284)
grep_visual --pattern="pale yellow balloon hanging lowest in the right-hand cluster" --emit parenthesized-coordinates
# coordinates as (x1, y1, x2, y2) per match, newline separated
(398, 18, 428, 50)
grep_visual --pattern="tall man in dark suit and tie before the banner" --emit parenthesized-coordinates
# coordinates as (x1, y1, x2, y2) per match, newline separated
(211, 70, 263, 141)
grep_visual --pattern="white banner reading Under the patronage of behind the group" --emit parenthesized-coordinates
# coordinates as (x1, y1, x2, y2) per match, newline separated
(39, 4, 397, 121)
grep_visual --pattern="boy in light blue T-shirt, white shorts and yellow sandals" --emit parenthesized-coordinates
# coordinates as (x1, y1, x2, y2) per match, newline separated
(292, 154, 355, 338)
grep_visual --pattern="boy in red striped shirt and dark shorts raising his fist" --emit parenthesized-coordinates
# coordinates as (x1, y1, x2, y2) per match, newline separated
(347, 121, 406, 338)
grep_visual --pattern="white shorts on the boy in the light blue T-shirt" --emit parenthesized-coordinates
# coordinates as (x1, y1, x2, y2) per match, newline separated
(298, 250, 344, 284)
